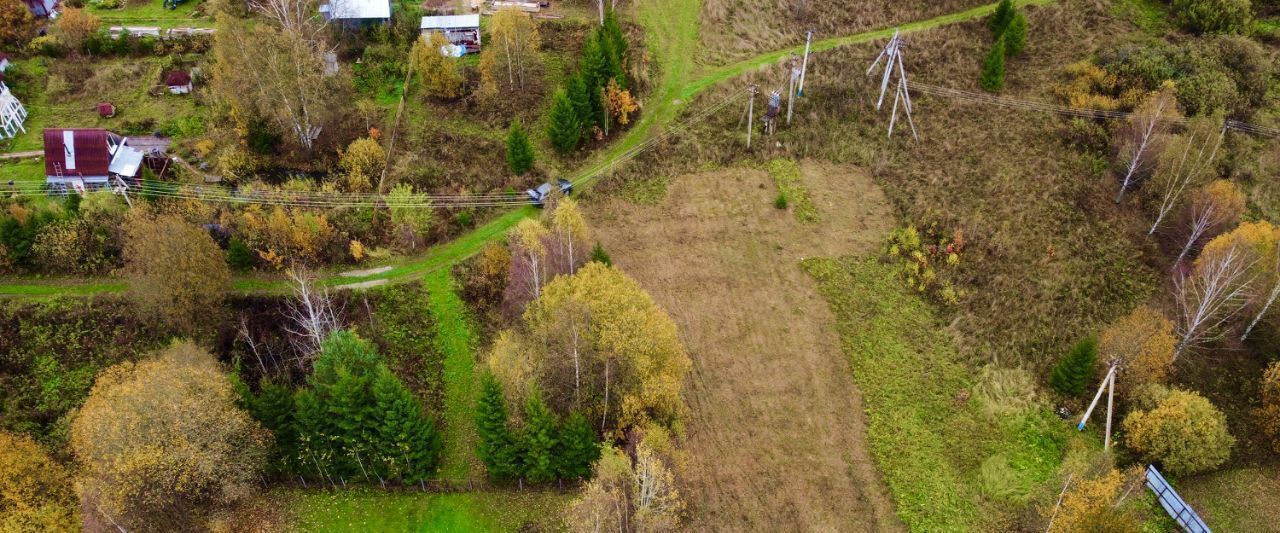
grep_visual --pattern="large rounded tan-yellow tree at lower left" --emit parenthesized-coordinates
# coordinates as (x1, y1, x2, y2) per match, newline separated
(70, 342, 270, 532)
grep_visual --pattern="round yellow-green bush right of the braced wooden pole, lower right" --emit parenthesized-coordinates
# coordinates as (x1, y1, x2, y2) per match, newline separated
(1123, 384, 1235, 474)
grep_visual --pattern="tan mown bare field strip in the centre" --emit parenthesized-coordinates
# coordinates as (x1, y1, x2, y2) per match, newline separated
(591, 163, 901, 532)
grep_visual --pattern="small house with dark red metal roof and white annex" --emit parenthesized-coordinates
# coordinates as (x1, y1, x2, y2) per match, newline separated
(45, 128, 142, 190)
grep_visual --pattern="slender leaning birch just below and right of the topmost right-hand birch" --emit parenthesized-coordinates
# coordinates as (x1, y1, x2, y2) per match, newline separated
(1147, 117, 1225, 234)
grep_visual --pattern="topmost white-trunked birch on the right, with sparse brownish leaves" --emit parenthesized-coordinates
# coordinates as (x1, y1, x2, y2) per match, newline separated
(1116, 85, 1181, 204)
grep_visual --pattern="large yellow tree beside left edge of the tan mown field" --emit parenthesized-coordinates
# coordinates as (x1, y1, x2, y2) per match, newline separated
(489, 263, 691, 431)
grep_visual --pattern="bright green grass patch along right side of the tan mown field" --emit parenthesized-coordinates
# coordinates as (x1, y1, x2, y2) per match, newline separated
(804, 259, 1098, 532)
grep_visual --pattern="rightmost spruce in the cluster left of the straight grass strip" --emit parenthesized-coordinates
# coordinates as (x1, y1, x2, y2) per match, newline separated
(374, 368, 440, 483)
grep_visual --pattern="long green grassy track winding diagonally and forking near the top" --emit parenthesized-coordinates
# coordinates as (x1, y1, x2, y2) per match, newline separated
(0, 0, 1055, 297)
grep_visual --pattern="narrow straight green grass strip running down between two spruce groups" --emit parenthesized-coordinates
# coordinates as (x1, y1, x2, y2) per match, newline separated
(424, 269, 480, 487)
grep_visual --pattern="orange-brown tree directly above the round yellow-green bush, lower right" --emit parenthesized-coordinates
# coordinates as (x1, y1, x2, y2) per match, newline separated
(1098, 305, 1178, 393)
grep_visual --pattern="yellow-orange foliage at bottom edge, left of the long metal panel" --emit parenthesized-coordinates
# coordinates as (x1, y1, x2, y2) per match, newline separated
(1050, 470, 1142, 533)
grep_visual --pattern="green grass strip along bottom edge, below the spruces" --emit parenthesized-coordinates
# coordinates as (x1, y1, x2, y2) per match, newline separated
(290, 491, 572, 533)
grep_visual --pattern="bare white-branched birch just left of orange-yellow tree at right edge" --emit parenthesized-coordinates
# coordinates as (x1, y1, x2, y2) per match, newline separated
(1174, 242, 1257, 361)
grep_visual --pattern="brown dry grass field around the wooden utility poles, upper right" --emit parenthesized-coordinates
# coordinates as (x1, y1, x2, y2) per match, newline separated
(614, 3, 1161, 372)
